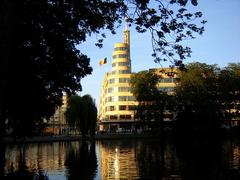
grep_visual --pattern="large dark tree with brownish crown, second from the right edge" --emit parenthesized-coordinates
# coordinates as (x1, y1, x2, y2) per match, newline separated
(173, 62, 223, 135)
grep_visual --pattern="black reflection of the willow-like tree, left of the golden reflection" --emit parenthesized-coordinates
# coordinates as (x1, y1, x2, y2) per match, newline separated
(65, 141, 97, 180)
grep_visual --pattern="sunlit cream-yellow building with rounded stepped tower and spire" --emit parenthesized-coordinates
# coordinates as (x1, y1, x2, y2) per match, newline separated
(98, 28, 176, 132)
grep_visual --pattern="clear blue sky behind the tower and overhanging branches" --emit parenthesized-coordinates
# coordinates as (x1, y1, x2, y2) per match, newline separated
(79, 0, 240, 106)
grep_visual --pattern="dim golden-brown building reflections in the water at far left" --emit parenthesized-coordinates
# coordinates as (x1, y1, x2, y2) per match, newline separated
(5, 142, 78, 173)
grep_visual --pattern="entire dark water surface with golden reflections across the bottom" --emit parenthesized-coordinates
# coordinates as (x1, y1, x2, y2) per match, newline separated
(0, 139, 240, 180)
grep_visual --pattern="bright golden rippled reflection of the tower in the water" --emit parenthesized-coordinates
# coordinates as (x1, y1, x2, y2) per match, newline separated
(99, 143, 139, 180)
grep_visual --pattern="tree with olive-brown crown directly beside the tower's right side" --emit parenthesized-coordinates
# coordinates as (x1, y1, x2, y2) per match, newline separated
(130, 71, 170, 133)
